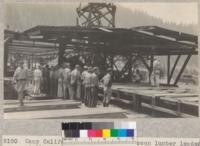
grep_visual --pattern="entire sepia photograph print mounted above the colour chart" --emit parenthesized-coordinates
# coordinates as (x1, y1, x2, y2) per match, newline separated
(3, 2, 199, 120)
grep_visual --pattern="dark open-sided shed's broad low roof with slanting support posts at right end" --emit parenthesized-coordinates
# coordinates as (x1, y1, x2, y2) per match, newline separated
(5, 26, 198, 85)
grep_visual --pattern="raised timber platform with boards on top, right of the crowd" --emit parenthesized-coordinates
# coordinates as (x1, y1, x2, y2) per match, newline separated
(108, 84, 199, 117)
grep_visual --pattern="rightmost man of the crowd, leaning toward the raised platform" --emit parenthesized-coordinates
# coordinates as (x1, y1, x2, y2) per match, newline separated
(101, 68, 112, 107)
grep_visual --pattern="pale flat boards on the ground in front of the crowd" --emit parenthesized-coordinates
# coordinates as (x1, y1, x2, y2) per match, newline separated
(4, 99, 149, 119)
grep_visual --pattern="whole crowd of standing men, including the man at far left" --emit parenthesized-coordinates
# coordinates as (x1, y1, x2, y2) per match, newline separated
(13, 62, 112, 107)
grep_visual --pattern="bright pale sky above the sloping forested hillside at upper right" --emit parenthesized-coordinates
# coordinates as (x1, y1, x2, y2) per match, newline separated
(120, 2, 198, 24)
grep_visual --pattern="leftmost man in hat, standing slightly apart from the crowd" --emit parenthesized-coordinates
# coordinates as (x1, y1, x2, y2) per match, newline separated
(13, 62, 28, 106)
